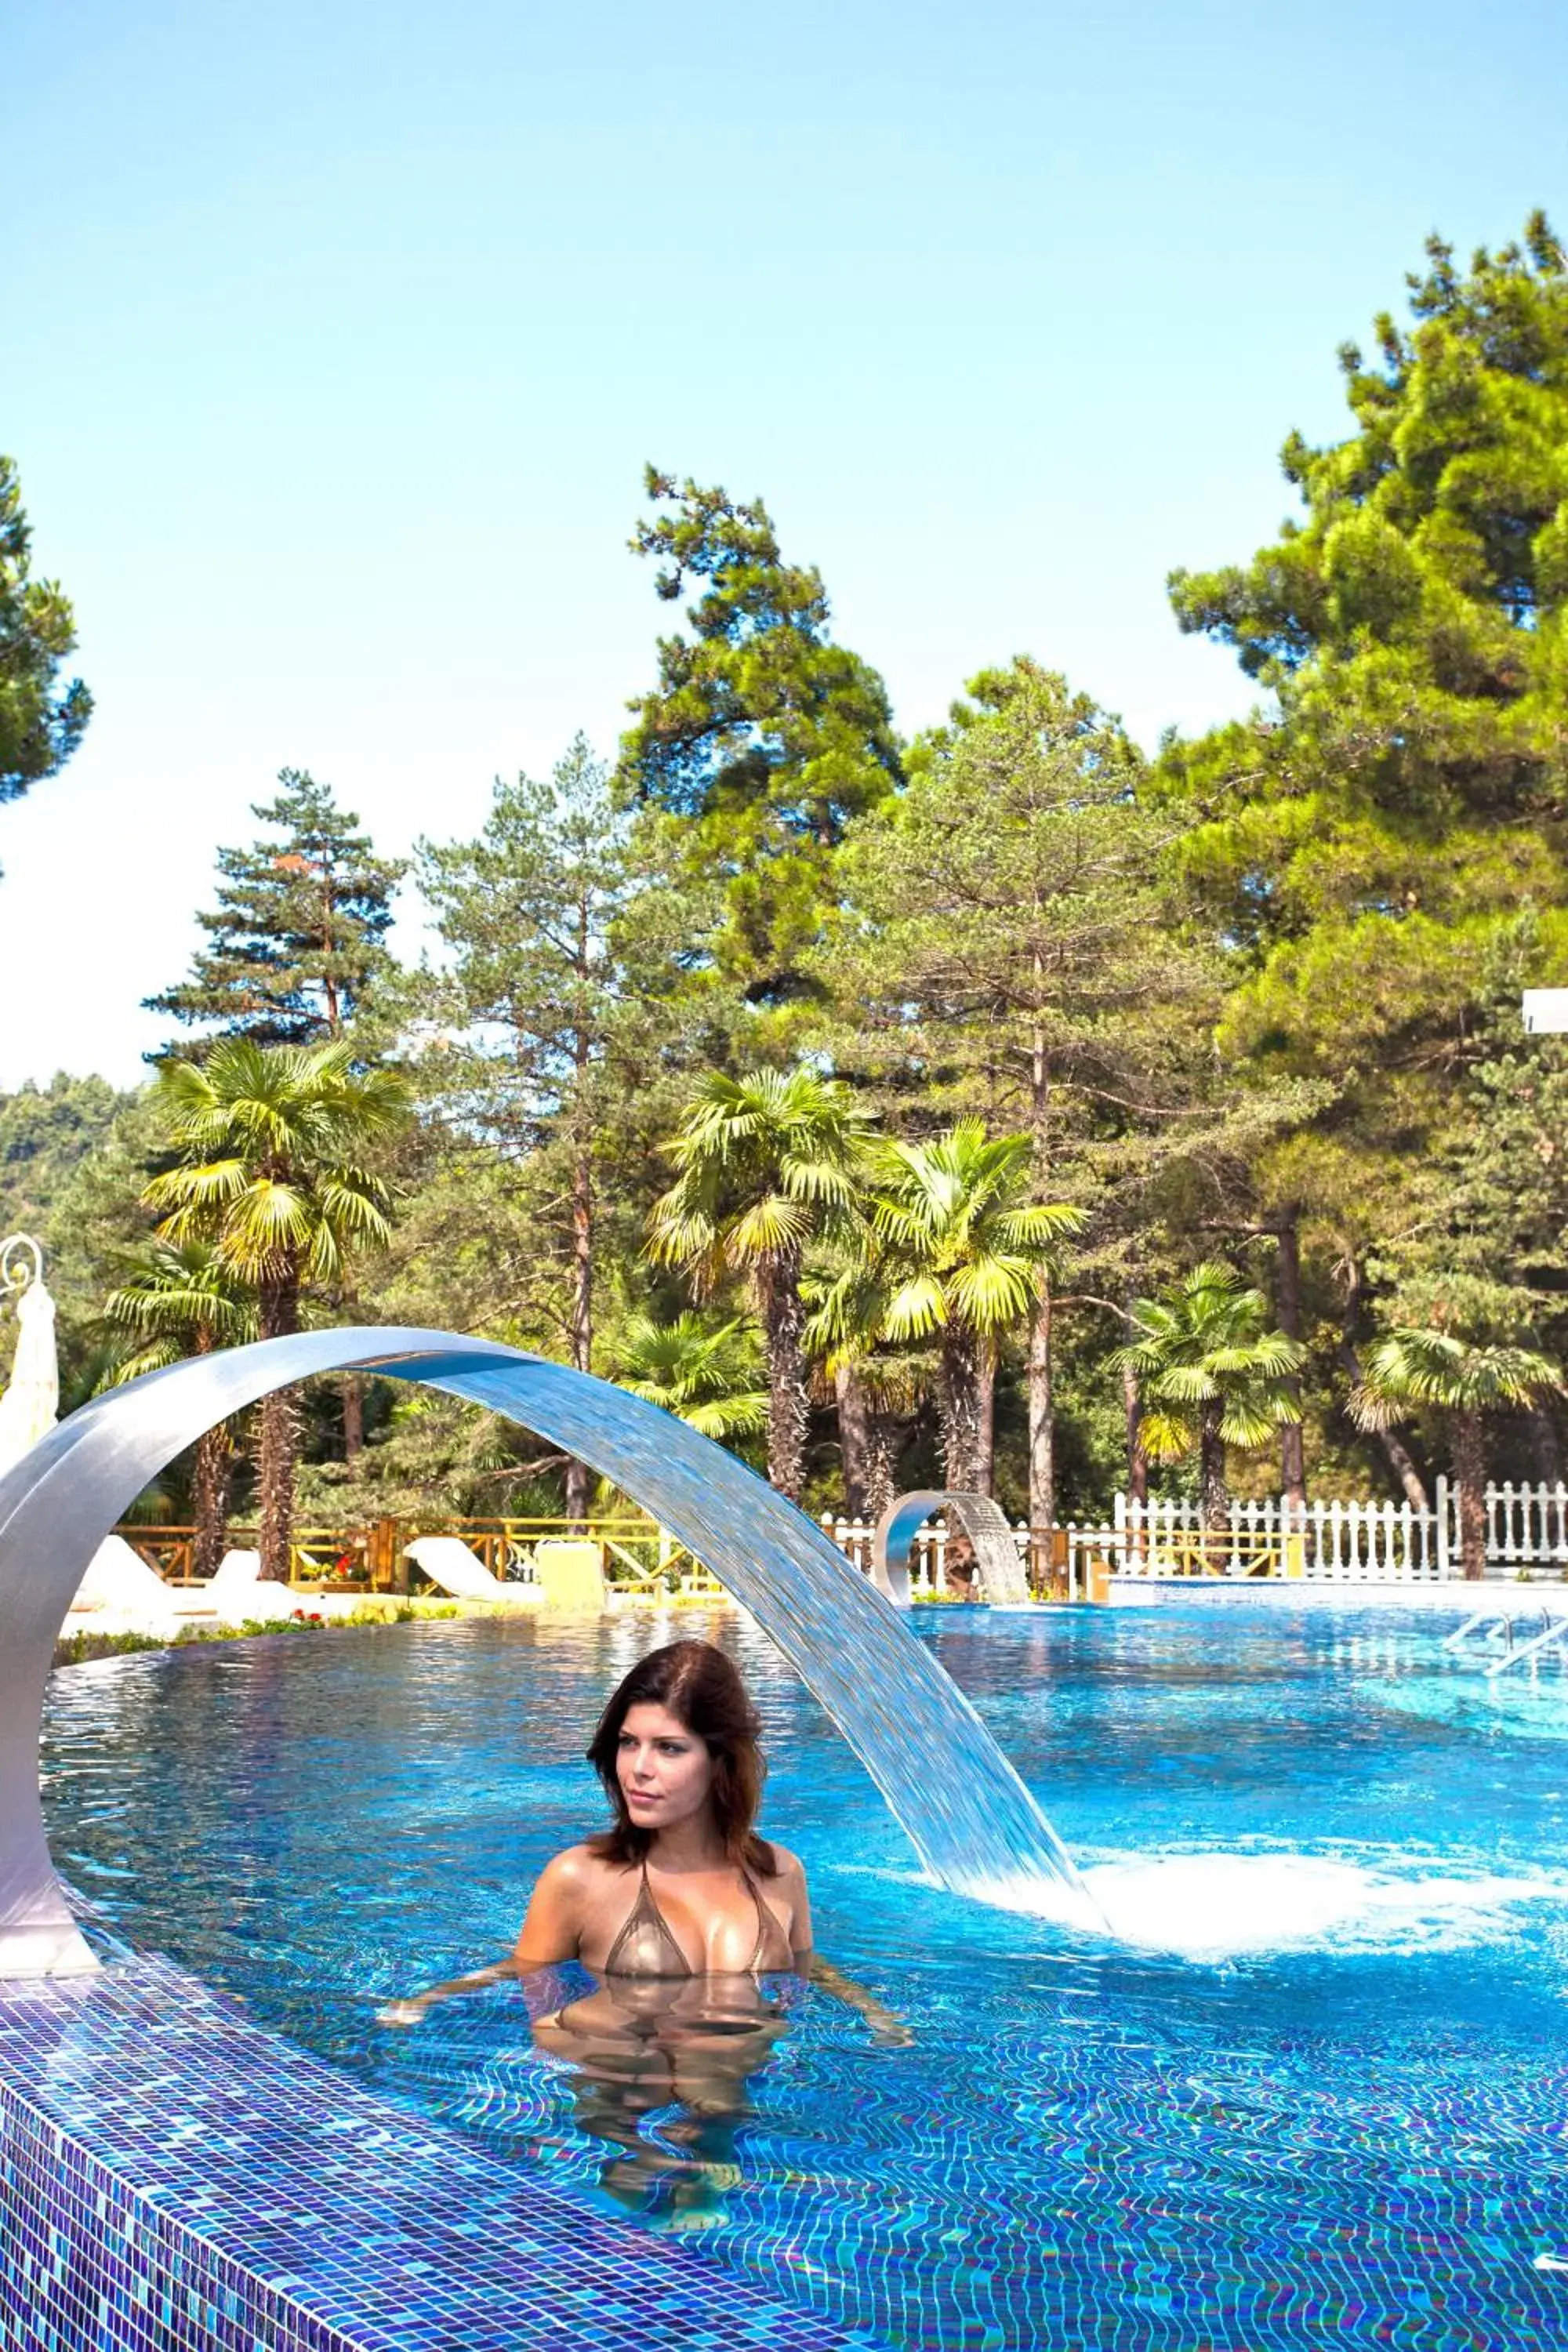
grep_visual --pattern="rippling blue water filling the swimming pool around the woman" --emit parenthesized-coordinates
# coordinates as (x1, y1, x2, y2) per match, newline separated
(45, 1609, 1568, 2352)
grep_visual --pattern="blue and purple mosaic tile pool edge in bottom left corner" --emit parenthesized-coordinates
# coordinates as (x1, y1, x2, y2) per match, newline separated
(0, 1959, 874, 2352)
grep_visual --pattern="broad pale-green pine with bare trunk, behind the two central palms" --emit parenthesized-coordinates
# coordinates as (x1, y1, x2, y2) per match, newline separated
(818, 656, 1302, 1526)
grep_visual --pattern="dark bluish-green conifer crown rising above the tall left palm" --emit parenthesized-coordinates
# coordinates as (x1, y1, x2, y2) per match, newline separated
(146, 767, 407, 1044)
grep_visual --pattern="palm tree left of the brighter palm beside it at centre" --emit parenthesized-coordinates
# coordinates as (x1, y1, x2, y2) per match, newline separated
(649, 1070, 867, 1503)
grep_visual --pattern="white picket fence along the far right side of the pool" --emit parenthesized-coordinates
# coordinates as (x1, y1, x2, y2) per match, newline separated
(822, 1477, 1568, 1595)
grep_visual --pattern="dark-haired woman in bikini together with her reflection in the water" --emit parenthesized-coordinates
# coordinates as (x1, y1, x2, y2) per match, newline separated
(383, 1642, 902, 2223)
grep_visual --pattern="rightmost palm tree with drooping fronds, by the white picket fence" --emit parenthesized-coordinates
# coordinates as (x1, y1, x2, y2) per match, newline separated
(1349, 1324, 1561, 1578)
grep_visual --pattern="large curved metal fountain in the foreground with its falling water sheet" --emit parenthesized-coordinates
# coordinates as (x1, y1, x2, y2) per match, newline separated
(0, 1329, 1100, 1978)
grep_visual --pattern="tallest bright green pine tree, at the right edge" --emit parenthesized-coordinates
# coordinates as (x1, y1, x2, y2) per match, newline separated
(1159, 216, 1568, 1496)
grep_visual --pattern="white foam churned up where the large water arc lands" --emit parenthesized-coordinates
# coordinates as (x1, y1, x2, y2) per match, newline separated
(1083, 1853, 1568, 1962)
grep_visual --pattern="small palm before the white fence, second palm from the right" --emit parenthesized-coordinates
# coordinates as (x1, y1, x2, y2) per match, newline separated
(1109, 1258, 1305, 1536)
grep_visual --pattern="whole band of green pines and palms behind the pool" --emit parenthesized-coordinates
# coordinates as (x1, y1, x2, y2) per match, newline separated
(24, 289, 1568, 1524)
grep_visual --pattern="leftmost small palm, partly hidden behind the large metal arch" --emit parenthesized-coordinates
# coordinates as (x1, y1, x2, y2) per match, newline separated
(99, 1240, 256, 1576)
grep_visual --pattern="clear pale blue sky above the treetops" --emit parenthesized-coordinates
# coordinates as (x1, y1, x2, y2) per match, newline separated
(0, 0, 1568, 1087)
